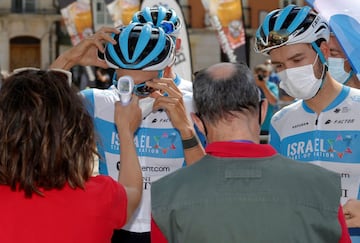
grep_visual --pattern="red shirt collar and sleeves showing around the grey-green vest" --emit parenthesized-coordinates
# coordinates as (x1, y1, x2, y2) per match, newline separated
(151, 142, 351, 243)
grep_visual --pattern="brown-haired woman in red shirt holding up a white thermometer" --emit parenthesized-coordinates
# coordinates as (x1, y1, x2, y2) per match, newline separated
(0, 68, 142, 243)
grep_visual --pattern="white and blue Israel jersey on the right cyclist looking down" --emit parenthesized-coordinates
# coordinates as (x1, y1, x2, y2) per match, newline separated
(269, 86, 360, 204)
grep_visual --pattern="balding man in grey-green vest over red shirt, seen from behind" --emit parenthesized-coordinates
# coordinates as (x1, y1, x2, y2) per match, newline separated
(152, 63, 349, 243)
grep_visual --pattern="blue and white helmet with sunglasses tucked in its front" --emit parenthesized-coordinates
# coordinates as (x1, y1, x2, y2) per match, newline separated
(255, 5, 330, 53)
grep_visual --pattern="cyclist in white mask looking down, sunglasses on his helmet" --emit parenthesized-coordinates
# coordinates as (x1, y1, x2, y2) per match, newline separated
(255, 5, 360, 241)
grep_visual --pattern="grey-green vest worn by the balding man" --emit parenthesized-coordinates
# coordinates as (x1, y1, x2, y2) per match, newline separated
(152, 151, 341, 243)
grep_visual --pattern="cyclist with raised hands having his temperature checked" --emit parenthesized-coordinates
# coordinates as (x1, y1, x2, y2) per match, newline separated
(52, 23, 204, 243)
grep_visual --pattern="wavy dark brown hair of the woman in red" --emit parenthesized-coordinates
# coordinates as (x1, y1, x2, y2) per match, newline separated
(0, 70, 98, 197)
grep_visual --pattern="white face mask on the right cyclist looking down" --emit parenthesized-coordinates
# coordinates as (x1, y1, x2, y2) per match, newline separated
(278, 56, 323, 100)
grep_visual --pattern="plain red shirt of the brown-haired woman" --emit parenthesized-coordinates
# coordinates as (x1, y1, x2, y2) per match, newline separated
(0, 176, 127, 243)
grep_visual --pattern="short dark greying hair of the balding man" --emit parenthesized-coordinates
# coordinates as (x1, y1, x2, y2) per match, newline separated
(193, 63, 260, 124)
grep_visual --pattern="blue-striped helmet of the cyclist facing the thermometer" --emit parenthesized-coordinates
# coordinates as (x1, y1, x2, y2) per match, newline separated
(104, 23, 175, 71)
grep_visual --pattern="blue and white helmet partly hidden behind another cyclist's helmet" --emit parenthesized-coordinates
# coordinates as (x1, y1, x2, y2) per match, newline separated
(132, 6, 181, 37)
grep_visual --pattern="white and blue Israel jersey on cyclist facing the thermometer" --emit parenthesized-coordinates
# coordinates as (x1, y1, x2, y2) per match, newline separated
(81, 79, 193, 232)
